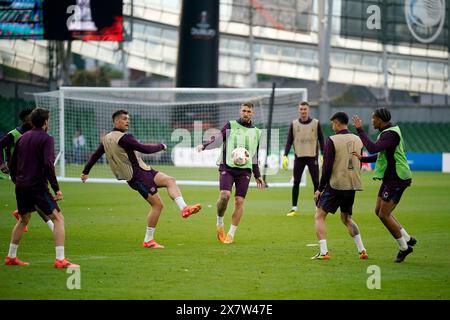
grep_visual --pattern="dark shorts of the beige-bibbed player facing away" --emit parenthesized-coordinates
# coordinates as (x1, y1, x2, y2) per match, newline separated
(317, 187, 355, 215)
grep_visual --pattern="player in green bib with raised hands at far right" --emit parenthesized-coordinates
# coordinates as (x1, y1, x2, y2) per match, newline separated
(352, 108, 417, 263)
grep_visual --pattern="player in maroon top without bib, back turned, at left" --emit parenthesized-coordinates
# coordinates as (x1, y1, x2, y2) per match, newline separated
(5, 108, 79, 268)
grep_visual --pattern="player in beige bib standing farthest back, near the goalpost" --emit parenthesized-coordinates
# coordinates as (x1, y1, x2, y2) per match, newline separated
(282, 101, 324, 217)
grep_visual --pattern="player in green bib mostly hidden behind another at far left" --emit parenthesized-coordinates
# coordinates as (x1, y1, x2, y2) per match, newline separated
(0, 109, 54, 232)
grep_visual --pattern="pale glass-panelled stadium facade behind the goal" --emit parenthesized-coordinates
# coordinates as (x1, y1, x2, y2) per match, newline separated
(0, 0, 449, 99)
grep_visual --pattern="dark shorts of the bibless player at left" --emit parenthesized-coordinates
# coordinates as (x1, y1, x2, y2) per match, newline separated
(16, 186, 61, 215)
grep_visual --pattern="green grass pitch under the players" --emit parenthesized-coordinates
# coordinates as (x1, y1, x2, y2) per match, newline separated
(0, 168, 450, 300)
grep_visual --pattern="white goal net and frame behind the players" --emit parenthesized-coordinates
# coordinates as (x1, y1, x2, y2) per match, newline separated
(34, 87, 307, 187)
